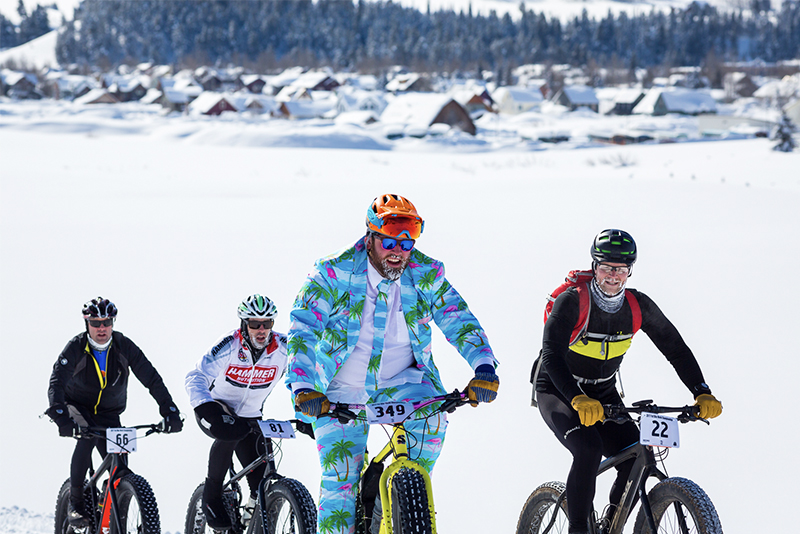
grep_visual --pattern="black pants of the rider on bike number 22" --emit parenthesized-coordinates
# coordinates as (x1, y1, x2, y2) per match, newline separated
(538, 390, 639, 532)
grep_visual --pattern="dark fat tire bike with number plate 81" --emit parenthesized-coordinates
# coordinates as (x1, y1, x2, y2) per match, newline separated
(184, 419, 317, 534)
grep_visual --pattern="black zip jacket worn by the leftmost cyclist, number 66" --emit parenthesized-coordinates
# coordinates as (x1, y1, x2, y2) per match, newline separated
(47, 331, 177, 417)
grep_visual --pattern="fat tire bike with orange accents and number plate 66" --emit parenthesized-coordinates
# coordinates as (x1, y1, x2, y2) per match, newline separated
(55, 423, 164, 534)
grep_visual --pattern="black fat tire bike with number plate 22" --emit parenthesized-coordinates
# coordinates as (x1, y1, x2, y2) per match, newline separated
(517, 400, 722, 534)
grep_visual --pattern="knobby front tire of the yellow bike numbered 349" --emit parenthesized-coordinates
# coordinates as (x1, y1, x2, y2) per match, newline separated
(391, 468, 433, 534)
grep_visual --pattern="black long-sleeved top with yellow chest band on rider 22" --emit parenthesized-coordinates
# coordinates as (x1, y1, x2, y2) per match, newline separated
(536, 288, 711, 401)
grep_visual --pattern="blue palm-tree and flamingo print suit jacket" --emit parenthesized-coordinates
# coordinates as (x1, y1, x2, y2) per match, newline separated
(286, 238, 497, 393)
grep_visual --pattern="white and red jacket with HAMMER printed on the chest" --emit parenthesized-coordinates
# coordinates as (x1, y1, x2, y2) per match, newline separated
(186, 329, 287, 418)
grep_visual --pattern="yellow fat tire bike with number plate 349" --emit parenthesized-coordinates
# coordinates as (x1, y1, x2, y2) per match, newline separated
(323, 390, 470, 534)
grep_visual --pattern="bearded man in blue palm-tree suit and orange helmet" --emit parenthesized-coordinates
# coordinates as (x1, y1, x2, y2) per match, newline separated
(287, 194, 499, 532)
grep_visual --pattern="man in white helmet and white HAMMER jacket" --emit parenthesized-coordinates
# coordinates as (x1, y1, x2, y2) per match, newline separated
(186, 294, 286, 530)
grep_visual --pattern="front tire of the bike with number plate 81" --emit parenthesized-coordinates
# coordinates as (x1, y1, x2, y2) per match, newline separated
(258, 478, 317, 534)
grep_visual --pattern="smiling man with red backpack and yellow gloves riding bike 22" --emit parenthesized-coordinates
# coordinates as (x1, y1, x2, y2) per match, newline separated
(536, 229, 722, 533)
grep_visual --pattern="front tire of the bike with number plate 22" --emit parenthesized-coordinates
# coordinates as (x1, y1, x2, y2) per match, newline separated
(633, 477, 722, 534)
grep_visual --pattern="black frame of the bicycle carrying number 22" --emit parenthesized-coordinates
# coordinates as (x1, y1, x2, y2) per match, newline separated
(592, 442, 667, 534)
